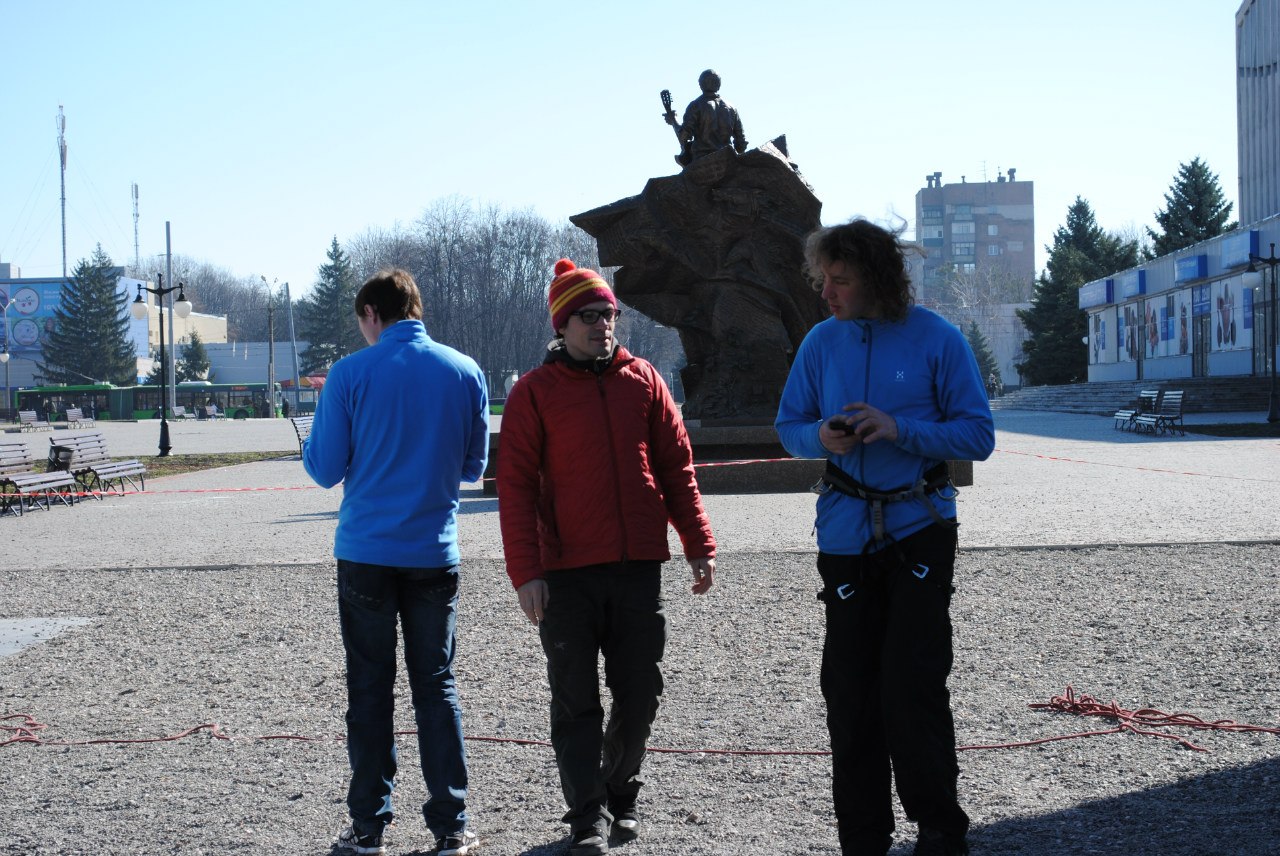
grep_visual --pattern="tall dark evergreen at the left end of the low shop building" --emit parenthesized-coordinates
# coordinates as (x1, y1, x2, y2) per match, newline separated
(1018, 197, 1138, 384)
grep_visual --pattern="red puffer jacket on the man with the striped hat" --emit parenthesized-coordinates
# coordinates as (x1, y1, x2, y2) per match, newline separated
(498, 347, 716, 589)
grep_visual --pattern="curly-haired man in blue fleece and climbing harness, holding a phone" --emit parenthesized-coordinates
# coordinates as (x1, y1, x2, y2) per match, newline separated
(776, 219, 995, 856)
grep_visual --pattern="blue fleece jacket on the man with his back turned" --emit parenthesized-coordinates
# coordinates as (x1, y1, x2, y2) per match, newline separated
(302, 321, 489, 568)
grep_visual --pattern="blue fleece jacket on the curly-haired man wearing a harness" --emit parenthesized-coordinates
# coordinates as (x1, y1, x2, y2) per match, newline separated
(774, 306, 996, 555)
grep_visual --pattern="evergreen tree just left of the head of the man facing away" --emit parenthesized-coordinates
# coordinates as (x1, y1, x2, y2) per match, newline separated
(297, 235, 365, 372)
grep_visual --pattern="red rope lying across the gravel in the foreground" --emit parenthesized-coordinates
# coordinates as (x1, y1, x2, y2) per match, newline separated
(0, 685, 1280, 756)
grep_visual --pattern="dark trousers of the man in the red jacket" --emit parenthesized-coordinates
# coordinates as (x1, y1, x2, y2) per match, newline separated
(539, 562, 667, 832)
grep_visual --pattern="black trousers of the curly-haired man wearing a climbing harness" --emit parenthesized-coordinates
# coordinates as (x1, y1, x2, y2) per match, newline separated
(818, 523, 969, 856)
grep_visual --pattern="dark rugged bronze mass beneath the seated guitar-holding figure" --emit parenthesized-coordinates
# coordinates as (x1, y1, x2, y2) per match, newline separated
(570, 137, 827, 426)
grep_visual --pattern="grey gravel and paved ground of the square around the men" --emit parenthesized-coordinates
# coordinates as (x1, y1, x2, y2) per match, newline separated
(0, 413, 1280, 856)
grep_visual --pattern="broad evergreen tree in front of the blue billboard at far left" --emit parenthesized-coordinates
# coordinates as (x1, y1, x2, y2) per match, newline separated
(40, 246, 138, 386)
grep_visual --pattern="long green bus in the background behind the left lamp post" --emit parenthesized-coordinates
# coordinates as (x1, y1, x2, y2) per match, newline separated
(13, 380, 283, 422)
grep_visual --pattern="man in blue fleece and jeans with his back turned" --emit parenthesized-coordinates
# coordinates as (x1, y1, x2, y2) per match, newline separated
(302, 270, 489, 856)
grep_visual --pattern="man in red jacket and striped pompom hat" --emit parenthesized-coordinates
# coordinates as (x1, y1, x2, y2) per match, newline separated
(498, 258, 716, 856)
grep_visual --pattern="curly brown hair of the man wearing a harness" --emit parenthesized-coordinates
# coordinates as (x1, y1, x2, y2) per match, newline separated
(804, 218, 918, 321)
